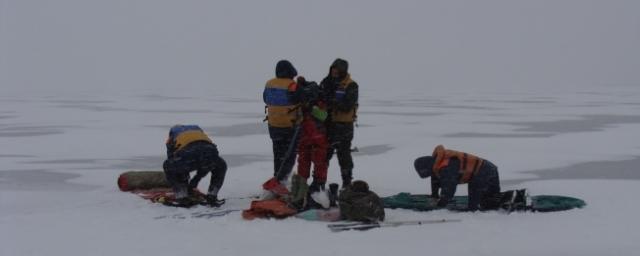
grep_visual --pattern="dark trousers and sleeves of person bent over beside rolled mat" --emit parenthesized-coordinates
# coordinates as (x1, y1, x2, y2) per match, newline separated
(163, 142, 227, 195)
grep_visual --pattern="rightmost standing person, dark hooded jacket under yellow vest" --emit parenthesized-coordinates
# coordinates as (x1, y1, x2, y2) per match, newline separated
(320, 59, 358, 188)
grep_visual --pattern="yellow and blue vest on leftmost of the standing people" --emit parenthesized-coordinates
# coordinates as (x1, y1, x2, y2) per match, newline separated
(265, 78, 299, 128)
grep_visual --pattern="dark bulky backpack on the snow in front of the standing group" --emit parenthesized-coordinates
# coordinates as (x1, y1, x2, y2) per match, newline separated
(338, 180, 384, 222)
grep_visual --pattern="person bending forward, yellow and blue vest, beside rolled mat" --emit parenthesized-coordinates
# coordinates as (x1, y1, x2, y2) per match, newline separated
(163, 125, 227, 207)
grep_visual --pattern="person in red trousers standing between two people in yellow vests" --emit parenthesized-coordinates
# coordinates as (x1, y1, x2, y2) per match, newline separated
(298, 77, 329, 192)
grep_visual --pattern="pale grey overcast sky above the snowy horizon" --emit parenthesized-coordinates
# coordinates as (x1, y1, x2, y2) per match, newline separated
(0, 0, 640, 94)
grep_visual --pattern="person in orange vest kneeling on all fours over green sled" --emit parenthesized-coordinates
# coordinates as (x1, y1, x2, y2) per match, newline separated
(414, 145, 501, 211)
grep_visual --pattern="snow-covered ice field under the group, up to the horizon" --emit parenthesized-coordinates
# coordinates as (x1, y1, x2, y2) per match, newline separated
(0, 87, 640, 255)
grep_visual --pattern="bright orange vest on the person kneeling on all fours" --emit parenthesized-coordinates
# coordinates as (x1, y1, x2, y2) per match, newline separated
(432, 145, 484, 184)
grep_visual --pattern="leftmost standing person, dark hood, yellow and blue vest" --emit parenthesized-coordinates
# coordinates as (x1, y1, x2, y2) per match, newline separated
(262, 60, 301, 194)
